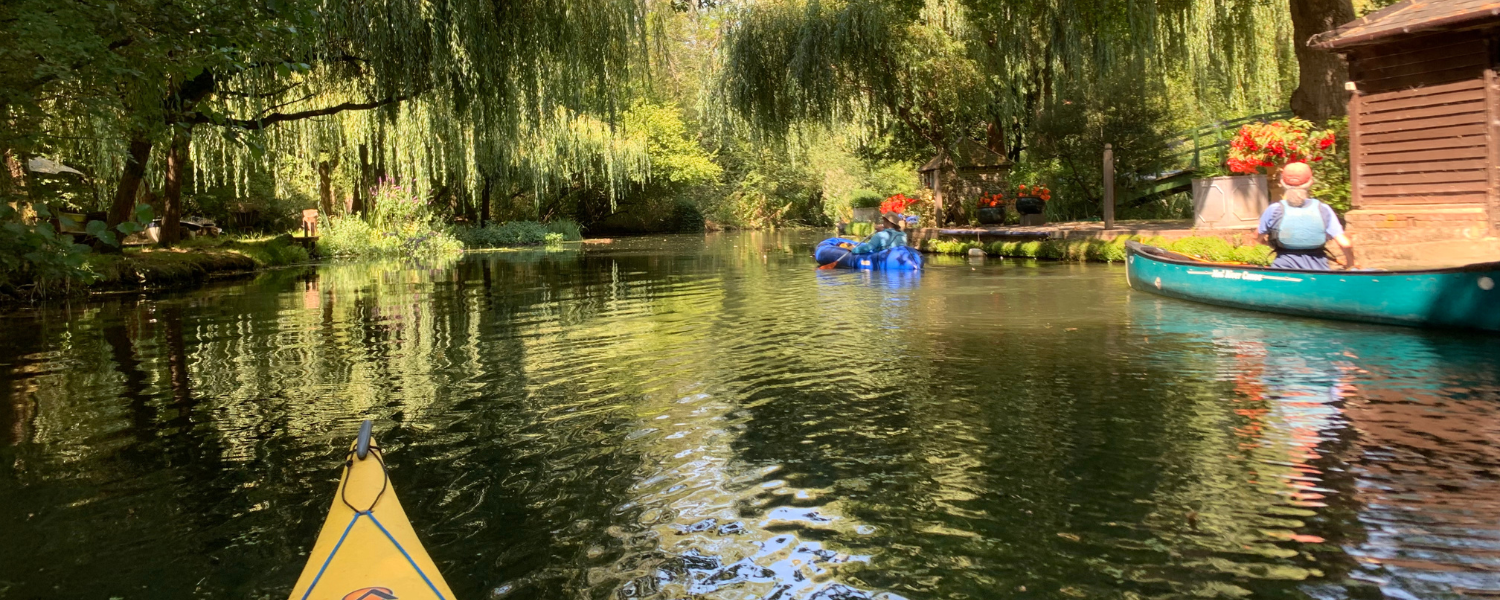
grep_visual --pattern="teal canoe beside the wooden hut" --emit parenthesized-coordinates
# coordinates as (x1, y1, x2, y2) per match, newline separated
(1125, 242, 1500, 332)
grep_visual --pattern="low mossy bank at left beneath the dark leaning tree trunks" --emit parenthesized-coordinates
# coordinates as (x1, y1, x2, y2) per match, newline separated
(89, 236, 309, 290)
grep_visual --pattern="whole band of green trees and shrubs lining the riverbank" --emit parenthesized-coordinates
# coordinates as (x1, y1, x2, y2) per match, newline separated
(0, 0, 1385, 291)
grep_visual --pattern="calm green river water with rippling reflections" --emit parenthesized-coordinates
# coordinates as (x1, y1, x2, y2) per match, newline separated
(0, 234, 1500, 600)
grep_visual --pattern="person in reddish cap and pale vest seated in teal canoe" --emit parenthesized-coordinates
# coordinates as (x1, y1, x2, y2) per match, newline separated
(1256, 162, 1355, 272)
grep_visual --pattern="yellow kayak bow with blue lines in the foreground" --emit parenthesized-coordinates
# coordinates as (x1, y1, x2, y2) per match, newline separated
(290, 422, 453, 600)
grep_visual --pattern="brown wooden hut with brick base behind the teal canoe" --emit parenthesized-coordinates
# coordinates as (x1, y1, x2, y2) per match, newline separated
(1310, 0, 1500, 263)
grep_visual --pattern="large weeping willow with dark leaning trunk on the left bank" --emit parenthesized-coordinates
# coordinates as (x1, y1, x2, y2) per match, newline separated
(0, 0, 647, 243)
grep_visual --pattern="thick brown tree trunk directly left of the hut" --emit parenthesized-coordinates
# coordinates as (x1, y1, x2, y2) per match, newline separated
(1289, 0, 1355, 123)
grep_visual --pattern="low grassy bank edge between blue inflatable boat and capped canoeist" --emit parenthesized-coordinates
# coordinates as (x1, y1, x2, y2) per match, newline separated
(923, 236, 1272, 266)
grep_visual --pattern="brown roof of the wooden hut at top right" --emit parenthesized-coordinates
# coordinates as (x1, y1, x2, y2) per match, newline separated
(1308, 0, 1500, 51)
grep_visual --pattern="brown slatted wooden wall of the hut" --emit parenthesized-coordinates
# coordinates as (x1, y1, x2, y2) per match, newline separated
(1349, 32, 1500, 222)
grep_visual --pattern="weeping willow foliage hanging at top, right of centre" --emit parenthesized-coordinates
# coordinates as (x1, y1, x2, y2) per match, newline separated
(720, 0, 1295, 152)
